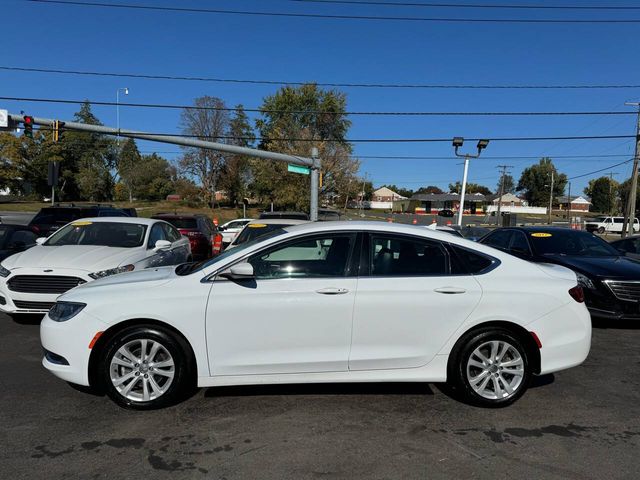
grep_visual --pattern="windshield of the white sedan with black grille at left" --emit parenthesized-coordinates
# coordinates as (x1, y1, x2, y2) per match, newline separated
(44, 220, 147, 248)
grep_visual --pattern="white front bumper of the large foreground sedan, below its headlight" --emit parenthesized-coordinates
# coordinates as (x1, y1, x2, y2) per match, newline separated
(40, 311, 107, 386)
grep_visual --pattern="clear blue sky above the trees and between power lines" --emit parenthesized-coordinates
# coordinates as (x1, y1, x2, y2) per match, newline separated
(0, 0, 640, 193)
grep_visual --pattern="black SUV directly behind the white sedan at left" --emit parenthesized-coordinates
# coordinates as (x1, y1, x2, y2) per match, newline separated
(29, 204, 137, 237)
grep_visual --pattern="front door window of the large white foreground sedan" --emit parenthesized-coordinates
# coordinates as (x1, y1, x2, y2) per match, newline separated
(248, 234, 355, 280)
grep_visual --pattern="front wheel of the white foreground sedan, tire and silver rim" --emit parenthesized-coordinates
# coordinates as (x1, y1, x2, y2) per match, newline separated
(98, 326, 192, 410)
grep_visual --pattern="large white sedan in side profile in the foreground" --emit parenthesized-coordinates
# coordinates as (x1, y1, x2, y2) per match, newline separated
(40, 222, 591, 409)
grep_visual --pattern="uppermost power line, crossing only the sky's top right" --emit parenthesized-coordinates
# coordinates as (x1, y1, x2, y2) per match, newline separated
(289, 0, 640, 10)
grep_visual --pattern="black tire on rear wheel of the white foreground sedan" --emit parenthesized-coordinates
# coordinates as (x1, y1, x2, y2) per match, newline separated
(447, 327, 532, 408)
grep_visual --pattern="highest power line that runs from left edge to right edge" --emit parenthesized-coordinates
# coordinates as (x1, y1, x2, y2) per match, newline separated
(5, 65, 640, 90)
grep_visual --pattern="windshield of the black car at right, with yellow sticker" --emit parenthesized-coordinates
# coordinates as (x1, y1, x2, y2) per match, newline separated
(528, 230, 620, 257)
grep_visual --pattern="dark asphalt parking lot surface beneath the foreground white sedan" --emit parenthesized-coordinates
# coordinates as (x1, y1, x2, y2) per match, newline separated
(0, 315, 640, 479)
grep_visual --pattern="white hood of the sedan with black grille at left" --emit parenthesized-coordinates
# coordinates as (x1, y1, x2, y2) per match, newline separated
(2, 245, 139, 272)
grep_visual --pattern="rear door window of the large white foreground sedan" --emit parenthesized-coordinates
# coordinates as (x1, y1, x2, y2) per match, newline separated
(369, 235, 449, 277)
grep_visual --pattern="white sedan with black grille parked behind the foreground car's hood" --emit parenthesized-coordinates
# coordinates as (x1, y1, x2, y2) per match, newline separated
(0, 217, 191, 315)
